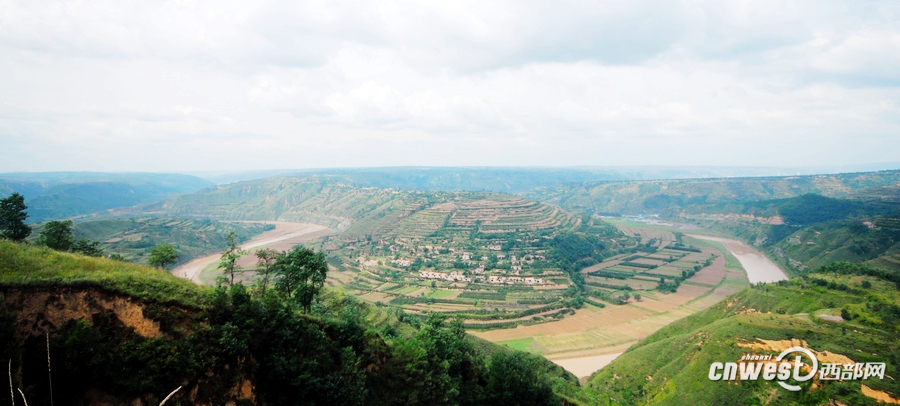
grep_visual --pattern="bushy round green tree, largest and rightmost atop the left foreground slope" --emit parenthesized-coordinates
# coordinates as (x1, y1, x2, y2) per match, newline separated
(274, 247, 328, 312)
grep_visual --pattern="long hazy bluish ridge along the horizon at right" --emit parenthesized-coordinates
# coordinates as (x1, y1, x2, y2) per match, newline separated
(522, 171, 900, 214)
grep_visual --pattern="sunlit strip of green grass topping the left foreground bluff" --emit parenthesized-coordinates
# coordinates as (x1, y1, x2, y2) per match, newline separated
(0, 240, 209, 308)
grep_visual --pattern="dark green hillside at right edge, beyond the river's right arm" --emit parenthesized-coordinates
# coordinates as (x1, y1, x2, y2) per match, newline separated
(664, 192, 900, 272)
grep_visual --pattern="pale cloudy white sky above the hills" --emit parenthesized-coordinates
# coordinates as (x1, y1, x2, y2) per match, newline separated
(0, 0, 900, 172)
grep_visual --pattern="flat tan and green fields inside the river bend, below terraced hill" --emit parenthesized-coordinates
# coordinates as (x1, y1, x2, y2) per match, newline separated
(470, 223, 748, 376)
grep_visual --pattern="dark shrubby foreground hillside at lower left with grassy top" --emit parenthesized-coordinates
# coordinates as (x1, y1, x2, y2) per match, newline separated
(0, 241, 579, 405)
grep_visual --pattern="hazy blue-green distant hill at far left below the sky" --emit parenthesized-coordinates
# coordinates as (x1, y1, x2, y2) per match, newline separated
(0, 172, 212, 223)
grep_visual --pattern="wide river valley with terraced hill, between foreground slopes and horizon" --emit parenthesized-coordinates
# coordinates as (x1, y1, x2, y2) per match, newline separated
(3, 167, 900, 404)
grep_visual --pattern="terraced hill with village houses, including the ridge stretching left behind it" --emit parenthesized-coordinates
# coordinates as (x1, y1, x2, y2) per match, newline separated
(130, 176, 637, 328)
